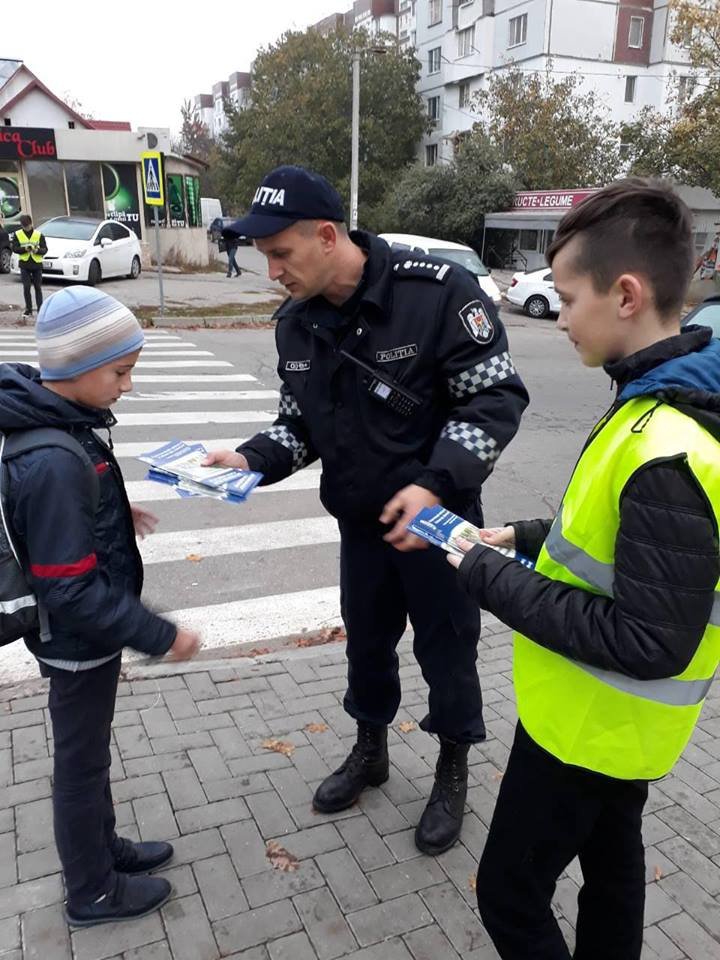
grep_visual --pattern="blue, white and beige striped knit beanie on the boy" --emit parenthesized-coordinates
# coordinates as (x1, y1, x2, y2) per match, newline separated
(35, 286, 145, 380)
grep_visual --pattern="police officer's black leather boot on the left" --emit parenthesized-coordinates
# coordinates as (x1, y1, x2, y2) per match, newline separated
(313, 723, 390, 813)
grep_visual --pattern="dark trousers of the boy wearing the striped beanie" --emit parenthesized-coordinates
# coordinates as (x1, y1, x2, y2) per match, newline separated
(40, 656, 121, 907)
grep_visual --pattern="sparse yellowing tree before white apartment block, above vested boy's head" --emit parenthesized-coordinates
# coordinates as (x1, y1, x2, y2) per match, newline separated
(472, 67, 620, 190)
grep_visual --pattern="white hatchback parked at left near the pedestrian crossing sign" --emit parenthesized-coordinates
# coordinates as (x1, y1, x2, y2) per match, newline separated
(10, 217, 141, 287)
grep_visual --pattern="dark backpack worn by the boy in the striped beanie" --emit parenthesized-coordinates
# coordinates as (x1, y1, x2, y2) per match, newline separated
(0, 427, 100, 646)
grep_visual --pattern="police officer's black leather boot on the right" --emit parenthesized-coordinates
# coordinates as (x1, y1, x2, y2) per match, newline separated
(415, 737, 470, 856)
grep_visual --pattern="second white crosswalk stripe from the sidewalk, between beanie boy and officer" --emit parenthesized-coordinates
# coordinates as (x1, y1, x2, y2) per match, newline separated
(138, 516, 340, 564)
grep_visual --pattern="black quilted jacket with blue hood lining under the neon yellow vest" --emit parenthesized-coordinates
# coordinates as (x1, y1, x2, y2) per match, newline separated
(459, 327, 720, 680)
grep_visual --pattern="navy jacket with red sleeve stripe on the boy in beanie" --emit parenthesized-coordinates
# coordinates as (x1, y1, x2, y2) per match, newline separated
(0, 364, 176, 661)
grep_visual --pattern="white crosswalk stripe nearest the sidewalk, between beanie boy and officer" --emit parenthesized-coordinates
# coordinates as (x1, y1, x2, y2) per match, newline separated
(163, 587, 342, 656)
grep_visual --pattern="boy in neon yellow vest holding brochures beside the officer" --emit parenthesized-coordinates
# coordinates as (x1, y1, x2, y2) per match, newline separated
(450, 178, 720, 960)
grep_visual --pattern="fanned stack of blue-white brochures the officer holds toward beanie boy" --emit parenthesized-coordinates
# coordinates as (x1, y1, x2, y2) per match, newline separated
(138, 440, 263, 503)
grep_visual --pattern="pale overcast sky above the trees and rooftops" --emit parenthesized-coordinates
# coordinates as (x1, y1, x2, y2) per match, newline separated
(13, 0, 352, 131)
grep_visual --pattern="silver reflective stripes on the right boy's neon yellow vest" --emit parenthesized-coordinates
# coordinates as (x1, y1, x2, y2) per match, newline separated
(545, 510, 720, 707)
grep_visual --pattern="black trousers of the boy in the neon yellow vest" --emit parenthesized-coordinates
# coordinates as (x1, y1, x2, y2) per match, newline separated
(477, 723, 648, 960)
